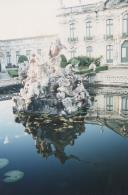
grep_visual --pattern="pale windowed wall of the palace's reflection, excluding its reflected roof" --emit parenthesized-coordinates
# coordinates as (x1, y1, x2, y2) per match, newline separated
(89, 87, 128, 119)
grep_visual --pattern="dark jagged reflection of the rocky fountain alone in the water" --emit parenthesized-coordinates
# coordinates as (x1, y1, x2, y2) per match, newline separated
(16, 115, 85, 164)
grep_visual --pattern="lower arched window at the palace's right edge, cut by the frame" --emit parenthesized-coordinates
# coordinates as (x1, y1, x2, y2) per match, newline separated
(121, 41, 128, 63)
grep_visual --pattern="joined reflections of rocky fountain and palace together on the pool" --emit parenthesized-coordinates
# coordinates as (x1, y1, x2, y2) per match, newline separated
(15, 88, 128, 164)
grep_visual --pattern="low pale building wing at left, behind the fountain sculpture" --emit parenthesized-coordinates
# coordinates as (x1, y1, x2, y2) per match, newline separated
(0, 35, 56, 71)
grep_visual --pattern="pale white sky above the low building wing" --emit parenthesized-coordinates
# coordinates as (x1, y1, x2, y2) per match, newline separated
(0, 0, 102, 40)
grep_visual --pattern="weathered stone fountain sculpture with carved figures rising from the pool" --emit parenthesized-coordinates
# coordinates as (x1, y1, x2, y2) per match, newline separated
(14, 40, 89, 115)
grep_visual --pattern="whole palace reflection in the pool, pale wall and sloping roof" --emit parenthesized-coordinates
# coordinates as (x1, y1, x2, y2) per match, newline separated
(86, 87, 128, 136)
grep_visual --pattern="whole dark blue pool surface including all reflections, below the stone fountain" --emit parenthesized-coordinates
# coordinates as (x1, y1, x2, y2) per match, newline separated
(0, 89, 128, 195)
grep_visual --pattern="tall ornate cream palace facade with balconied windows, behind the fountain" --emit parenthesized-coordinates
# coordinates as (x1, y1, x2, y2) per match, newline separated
(58, 0, 128, 65)
